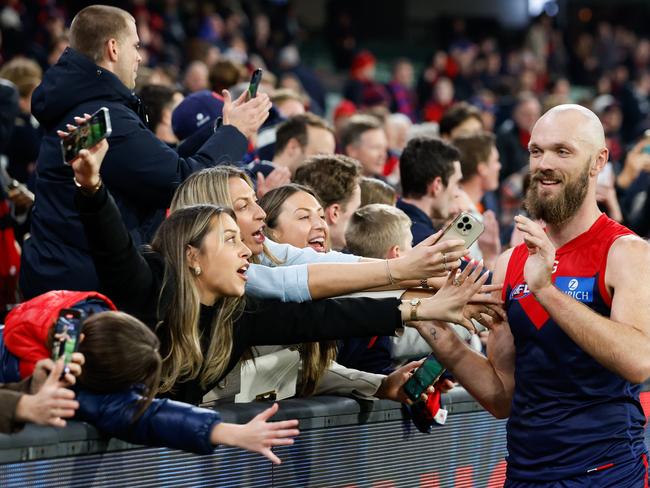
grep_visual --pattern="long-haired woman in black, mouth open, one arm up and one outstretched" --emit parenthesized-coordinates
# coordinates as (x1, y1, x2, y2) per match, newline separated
(67, 132, 500, 403)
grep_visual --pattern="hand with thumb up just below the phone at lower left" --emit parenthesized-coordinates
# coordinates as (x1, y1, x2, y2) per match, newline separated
(15, 359, 79, 427)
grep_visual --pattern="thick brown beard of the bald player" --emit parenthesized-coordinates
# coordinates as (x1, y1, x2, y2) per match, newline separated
(524, 164, 590, 225)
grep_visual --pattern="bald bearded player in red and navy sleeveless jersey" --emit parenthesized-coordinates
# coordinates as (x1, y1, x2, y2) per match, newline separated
(408, 105, 650, 488)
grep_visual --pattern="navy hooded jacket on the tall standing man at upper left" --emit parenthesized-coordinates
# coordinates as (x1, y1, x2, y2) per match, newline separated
(20, 48, 247, 298)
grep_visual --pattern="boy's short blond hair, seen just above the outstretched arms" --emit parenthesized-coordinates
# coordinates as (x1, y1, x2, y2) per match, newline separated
(345, 203, 411, 259)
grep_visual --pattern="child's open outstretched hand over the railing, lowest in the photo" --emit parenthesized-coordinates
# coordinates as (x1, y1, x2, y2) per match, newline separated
(210, 403, 300, 464)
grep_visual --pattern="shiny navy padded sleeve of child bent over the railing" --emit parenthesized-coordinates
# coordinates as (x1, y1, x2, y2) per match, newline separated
(74, 387, 221, 454)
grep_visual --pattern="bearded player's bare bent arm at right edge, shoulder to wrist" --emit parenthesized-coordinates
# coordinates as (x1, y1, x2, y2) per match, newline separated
(526, 236, 650, 383)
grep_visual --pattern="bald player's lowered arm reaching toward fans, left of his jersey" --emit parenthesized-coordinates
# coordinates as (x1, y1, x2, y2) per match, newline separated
(408, 251, 515, 418)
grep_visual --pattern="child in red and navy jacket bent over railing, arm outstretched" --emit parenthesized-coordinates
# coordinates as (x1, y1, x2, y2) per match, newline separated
(0, 304, 298, 464)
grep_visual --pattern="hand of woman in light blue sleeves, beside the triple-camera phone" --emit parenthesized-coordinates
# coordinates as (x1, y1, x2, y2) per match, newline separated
(390, 231, 469, 281)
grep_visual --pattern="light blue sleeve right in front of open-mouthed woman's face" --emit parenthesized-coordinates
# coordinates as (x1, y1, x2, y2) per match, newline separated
(246, 264, 311, 302)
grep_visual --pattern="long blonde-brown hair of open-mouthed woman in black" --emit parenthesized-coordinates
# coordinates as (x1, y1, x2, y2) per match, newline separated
(151, 205, 244, 392)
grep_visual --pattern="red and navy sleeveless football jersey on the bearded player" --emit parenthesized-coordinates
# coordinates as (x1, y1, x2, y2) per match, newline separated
(503, 214, 645, 481)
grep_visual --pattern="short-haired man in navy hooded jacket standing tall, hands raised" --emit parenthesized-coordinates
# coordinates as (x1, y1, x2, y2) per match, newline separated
(20, 5, 271, 298)
